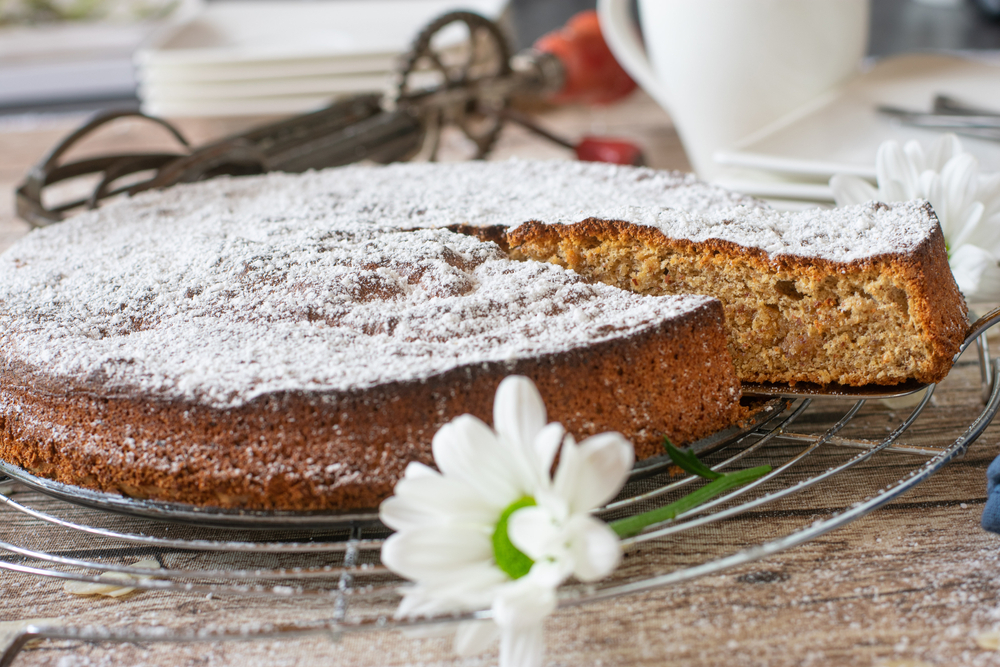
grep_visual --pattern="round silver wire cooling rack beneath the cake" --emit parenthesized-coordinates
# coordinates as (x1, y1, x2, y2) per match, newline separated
(0, 311, 1000, 667)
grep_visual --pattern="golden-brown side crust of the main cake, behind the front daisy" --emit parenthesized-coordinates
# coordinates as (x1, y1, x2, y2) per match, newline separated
(0, 301, 739, 510)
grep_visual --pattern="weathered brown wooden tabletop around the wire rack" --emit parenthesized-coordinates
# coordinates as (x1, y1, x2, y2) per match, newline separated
(0, 95, 1000, 667)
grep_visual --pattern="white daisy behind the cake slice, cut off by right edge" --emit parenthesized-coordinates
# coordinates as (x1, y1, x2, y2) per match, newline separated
(830, 134, 1000, 303)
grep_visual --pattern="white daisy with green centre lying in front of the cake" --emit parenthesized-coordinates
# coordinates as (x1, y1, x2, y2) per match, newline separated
(379, 376, 634, 667)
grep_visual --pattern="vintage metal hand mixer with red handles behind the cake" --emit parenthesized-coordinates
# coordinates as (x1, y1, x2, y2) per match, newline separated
(17, 12, 641, 227)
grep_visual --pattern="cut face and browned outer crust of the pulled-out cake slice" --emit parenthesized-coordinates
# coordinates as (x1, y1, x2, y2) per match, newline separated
(507, 203, 968, 386)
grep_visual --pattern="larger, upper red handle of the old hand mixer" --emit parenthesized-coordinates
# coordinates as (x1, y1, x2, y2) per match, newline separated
(535, 10, 635, 104)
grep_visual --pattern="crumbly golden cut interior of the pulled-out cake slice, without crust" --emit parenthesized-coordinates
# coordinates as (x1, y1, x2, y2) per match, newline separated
(511, 226, 933, 386)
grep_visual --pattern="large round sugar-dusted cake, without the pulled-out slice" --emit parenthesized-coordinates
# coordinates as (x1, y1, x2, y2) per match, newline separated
(0, 162, 745, 510)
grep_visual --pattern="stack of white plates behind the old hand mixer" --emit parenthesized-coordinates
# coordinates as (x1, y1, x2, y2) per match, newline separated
(135, 0, 507, 117)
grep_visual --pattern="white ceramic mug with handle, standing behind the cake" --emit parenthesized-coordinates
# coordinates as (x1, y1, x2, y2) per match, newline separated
(597, 0, 868, 179)
